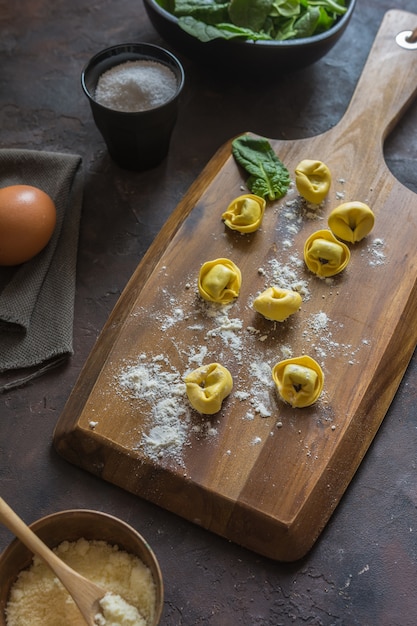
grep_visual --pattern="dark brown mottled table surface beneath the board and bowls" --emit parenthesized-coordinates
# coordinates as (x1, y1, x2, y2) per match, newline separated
(0, 0, 417, 626)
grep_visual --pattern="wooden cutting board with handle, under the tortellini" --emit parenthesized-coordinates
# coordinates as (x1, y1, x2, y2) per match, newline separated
(54, 11, 417, 561)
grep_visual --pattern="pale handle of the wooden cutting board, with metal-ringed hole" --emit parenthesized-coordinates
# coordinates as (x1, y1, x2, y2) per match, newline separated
(340, 10, 417, 149)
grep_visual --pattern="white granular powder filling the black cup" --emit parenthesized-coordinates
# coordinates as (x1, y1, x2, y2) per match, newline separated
(94, 59, 178, 113)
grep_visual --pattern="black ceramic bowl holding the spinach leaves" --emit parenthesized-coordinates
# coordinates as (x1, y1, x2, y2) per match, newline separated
(143, 0, 356, 72)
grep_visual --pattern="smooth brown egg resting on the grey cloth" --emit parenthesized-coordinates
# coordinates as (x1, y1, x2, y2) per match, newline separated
(0, 185, 56, 265)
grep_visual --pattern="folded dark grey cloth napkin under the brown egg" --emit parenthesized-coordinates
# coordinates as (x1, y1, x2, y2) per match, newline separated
(0, 149, 83, 392)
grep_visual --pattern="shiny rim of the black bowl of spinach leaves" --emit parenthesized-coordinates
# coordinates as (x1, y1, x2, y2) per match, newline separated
(143, 0, 356, 49)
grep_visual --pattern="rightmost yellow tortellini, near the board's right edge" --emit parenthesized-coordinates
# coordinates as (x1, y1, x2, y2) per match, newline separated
(327, 202, 375, 243)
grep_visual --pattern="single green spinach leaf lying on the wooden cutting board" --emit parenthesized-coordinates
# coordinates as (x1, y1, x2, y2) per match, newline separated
(232, 135, 291, 200)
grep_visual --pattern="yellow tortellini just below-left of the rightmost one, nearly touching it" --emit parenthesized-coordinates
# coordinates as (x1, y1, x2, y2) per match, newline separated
(304, 229, 350, 278)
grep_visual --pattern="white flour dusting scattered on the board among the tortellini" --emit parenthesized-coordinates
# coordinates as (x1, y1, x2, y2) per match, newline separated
(112, 180, 386, 468)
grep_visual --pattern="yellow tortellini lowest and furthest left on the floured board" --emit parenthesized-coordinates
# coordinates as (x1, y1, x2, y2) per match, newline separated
(184, 363, 233, 415)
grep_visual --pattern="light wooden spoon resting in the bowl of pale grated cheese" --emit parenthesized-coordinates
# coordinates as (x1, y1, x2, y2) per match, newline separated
(0, 498, 107, 626)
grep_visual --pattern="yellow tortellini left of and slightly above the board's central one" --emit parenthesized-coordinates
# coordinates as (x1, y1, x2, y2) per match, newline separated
(198, 258, 242, 304)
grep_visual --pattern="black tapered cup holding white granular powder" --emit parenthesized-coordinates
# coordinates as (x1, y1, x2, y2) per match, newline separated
(81, 43, 184, 171)
